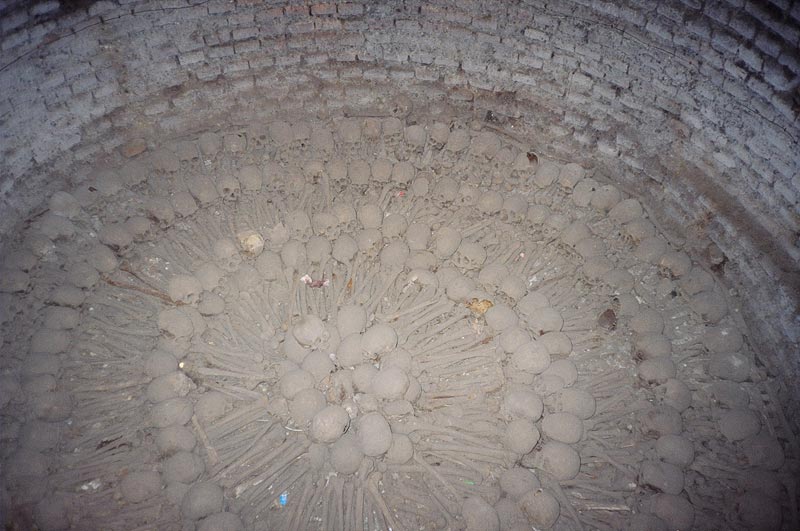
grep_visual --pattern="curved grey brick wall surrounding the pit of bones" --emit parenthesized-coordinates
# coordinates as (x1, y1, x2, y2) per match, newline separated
(0, 0, 800, 425)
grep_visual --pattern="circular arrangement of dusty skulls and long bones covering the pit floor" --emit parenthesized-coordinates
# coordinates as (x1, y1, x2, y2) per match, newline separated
(0, 118, 789, 530)
